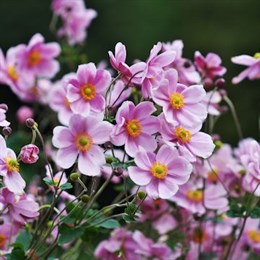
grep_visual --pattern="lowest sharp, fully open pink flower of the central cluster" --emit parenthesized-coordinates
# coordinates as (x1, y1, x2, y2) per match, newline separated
(128, 145, 192, 199)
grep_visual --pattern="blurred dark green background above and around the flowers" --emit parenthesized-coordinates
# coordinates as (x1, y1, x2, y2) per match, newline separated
(0, 0, 260, 145)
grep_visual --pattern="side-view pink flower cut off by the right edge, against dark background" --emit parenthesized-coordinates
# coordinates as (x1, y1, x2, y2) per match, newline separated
(231, 53, 260, 84)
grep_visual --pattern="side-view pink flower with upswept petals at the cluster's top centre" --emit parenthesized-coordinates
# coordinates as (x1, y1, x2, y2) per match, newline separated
(130, 42, 176, 98)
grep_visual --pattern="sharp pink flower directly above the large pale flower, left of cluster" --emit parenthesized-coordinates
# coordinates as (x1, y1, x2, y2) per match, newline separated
(67, 63, 111, 116)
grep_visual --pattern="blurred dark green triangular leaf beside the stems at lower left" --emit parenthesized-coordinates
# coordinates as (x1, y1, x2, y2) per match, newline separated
(58, 224, 84, 245)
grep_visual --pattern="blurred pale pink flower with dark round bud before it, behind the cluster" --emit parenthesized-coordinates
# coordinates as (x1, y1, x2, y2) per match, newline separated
(163, 40, 201, 85)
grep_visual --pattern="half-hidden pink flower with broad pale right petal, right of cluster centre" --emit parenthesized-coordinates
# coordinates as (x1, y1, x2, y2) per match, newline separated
(160, 114, 215, 161)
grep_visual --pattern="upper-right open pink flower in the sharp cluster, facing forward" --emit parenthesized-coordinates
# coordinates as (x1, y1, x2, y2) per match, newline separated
(152, 69, 207, 129)
